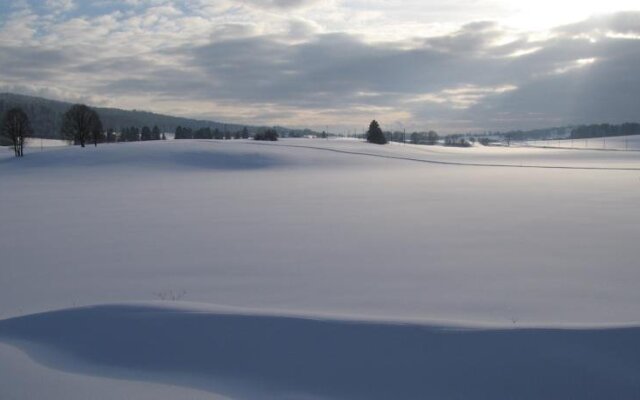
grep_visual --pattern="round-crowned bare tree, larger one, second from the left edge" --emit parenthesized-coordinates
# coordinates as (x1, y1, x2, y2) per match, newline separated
(62, 104, 102, 147)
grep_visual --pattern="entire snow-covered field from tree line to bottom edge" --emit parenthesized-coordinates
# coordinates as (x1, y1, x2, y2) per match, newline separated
(0, 139, 640, 399)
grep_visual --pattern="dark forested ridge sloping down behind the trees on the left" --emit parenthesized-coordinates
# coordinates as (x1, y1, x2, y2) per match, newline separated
(0, 93, 314, 139)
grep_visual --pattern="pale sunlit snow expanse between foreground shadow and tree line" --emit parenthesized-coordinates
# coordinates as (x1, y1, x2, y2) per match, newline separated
(0, 141, 640, 323)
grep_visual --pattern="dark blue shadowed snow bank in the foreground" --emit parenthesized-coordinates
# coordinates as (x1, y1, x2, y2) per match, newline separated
(0, 304, 640, 399)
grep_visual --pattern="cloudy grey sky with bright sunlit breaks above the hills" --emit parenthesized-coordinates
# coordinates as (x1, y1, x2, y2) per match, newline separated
(0, 0, 640, 132)
